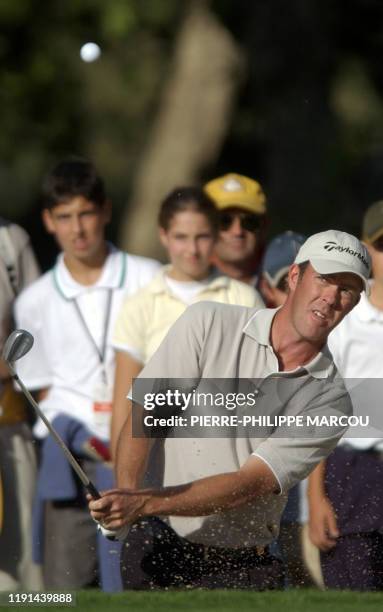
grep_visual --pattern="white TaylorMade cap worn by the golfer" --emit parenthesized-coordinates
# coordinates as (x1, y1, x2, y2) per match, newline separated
(294, 230, 371, 294)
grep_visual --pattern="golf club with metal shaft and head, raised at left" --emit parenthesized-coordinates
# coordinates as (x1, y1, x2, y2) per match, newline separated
(2, 329, 101, 499)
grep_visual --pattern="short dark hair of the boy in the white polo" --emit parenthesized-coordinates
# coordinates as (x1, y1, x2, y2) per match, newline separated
(42, 157, 106, 209)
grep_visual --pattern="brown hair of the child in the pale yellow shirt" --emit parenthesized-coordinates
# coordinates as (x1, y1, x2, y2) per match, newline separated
(158, 187, 218, 233)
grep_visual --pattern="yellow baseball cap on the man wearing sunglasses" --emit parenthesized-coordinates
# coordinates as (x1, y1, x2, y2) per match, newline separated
(204, 172, 266, 215)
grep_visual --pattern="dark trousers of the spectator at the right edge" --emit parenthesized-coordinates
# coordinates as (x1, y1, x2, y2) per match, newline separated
(321, 446, 383, 591)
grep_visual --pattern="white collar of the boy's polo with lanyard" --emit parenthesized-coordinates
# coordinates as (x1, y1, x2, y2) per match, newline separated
(52, 243, 126, 300)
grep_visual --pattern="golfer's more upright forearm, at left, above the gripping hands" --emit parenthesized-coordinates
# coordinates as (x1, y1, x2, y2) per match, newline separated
(115, 408, 152, 489)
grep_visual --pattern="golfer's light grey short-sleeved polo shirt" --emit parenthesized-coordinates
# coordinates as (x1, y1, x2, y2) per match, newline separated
(133, 302, 351, 547)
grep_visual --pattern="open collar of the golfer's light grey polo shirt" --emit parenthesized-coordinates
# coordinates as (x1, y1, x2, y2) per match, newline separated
(243, 308, 334, 378)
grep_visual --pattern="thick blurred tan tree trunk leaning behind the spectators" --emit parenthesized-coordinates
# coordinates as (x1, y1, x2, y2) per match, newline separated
(120, 0, 244, 257)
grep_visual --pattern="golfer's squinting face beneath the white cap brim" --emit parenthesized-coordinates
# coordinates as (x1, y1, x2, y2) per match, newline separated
(289, 264, 363, 343)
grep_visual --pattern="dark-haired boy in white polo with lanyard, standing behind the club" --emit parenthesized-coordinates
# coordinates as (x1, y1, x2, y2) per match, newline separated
(15, 159, 159, 590)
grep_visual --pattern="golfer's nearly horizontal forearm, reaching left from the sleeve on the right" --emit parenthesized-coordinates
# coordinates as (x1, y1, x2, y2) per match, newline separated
(144, 456, 278, 516)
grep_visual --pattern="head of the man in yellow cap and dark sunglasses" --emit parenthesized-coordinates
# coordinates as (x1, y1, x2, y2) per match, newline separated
(204, 173, 266, 284)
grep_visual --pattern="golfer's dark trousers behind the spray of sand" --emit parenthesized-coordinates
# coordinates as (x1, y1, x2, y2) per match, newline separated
(121, 517, 284, 590)
